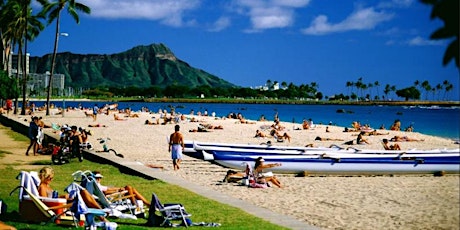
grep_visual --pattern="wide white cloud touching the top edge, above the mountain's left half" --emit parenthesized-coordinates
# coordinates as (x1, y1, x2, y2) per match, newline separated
(81, 0, 200, 26)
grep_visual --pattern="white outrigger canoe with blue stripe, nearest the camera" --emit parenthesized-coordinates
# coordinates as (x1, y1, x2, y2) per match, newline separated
(202, 147, 460, 174)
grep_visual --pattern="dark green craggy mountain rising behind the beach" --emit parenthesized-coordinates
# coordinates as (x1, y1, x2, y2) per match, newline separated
(30, 44, 235, 88)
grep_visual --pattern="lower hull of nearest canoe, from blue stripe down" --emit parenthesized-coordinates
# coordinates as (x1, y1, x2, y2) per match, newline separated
(209, 155, 460, 175)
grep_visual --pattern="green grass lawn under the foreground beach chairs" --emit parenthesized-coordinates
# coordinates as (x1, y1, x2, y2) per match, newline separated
(0, 130, 286, 229)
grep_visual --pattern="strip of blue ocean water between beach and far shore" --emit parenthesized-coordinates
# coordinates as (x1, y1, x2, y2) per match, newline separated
(34, 101, 460, 140)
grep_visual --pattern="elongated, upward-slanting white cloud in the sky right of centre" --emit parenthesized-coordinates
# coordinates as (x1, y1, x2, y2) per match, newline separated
(302, 7, 393, 35)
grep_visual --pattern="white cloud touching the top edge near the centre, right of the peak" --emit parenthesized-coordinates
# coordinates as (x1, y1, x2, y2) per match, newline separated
(234, 0, 310, 31)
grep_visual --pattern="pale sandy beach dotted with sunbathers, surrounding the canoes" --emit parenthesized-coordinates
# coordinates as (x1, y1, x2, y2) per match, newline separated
(2, 110, 460, 229)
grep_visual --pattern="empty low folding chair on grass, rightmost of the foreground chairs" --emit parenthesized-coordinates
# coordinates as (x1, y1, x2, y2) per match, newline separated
(149, 193, 192, 227)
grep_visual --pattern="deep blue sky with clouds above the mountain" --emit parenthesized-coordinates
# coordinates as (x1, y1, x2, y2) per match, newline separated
(28, 0, 460, 100)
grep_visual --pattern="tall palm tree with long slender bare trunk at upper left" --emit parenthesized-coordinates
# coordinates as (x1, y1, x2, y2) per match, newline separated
(37, 0, 91, 116)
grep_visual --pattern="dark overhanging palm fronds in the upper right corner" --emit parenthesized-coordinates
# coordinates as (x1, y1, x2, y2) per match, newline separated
(421, 0, 460, 70)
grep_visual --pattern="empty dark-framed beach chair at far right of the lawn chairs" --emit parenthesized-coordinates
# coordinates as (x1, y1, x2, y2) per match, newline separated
(147, 193, 192, 228)
